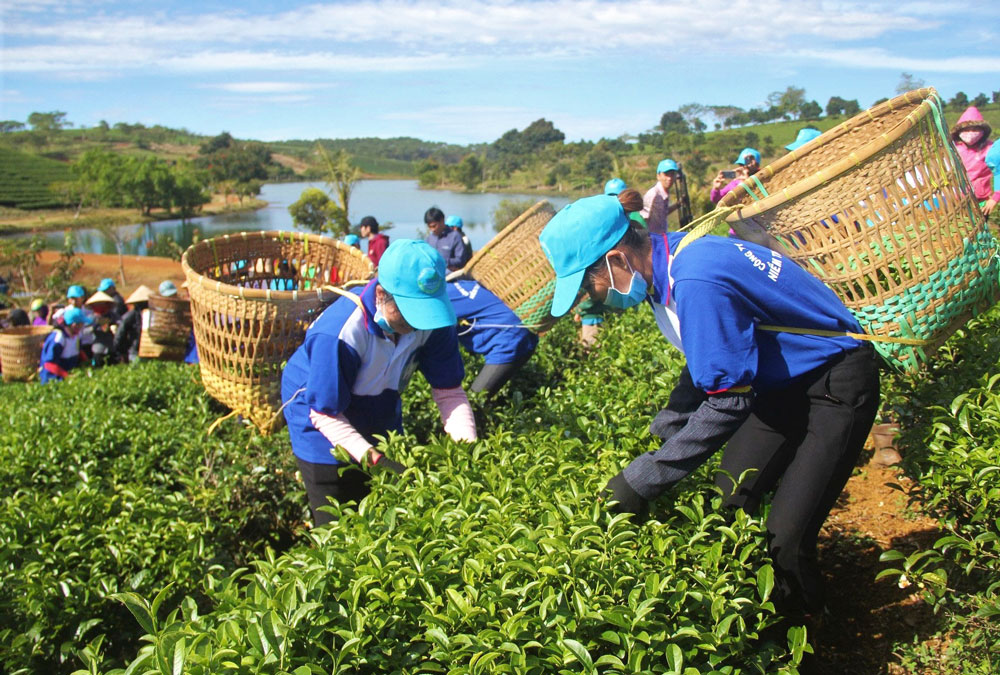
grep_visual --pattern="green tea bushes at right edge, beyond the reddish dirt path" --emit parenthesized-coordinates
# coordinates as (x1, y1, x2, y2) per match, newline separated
(881, 308, 1000, 674)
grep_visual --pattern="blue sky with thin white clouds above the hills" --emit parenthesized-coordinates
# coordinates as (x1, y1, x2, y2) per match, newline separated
(0, 0, 1000, 143)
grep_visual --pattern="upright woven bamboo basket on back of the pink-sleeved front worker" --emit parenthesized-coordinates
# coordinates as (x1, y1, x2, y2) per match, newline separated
(181, 231, 373, 434)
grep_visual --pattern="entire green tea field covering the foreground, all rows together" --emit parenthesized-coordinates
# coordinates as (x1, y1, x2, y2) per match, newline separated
(0, 311, 1000, 675)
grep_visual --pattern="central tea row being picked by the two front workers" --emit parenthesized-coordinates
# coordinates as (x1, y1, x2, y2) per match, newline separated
(99, 312, 807, 675)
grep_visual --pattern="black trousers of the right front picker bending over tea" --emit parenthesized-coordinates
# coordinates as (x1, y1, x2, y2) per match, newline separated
(716, 344, 880, 613)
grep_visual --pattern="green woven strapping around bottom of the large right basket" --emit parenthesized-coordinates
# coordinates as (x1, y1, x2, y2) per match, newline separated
(853, 231, 1000, 370)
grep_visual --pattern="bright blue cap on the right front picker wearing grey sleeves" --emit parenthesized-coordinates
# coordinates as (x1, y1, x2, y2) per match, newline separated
(538, 195, 629, 316)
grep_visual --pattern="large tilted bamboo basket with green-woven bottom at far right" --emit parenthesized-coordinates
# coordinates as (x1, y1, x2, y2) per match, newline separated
(720, 88, 998, 370)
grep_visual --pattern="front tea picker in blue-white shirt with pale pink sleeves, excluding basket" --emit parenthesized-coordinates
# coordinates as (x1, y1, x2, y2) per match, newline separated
(281, 239, 476, 525)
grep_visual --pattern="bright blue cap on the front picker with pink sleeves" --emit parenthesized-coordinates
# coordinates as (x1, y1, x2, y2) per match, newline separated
(377, 239, 457, 330)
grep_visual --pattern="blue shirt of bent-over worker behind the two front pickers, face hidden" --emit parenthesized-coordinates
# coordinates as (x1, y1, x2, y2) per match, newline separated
(448, 280, 538, 365)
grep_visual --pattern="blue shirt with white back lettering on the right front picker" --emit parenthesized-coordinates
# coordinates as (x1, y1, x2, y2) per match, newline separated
(650, 233, 863, 393)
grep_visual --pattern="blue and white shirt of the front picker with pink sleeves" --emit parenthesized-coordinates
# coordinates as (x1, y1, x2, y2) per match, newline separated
(281, 281, 465, 464)
